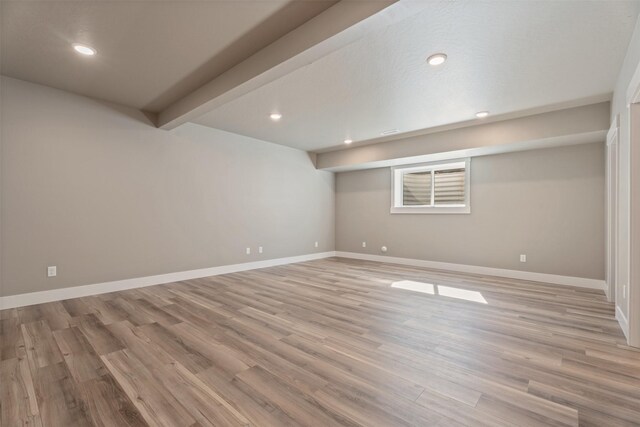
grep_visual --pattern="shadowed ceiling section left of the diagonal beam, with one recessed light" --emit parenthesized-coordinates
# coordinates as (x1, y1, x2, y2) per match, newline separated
(0, 0, 335, 112)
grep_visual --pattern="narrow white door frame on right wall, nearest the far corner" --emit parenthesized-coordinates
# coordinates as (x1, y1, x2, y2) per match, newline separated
(605, 115, 620, 302)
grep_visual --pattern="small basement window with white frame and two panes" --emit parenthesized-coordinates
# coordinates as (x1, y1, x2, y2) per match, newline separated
(391, 159, 471, 213)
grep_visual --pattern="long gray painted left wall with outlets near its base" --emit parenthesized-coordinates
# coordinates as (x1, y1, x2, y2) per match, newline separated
(0, 77, 335, 295)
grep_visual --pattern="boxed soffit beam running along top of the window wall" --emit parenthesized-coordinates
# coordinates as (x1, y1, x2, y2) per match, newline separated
(316, 101, 610, 172)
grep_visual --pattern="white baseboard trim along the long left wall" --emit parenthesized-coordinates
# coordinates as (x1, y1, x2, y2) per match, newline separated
(0, 251, 335, 310)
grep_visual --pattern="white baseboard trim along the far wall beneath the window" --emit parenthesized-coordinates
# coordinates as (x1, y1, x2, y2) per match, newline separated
(336, 251, 605, 292)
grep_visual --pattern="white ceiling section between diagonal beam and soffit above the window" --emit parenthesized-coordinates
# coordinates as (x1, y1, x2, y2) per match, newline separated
(195, 0, 640, 151)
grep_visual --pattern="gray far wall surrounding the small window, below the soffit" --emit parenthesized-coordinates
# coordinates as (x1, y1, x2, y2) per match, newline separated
(336, 143, 605, 279)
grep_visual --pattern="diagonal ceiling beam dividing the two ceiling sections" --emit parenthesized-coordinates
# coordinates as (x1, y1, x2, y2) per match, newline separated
(157, 0, 420, 129)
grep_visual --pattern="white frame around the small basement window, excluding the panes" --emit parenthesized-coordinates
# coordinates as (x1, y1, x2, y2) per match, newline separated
(391, 158, 471, 214)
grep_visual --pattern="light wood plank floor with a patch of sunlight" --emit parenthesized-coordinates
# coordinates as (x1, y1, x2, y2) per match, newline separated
(0, 258, 640, 427)
